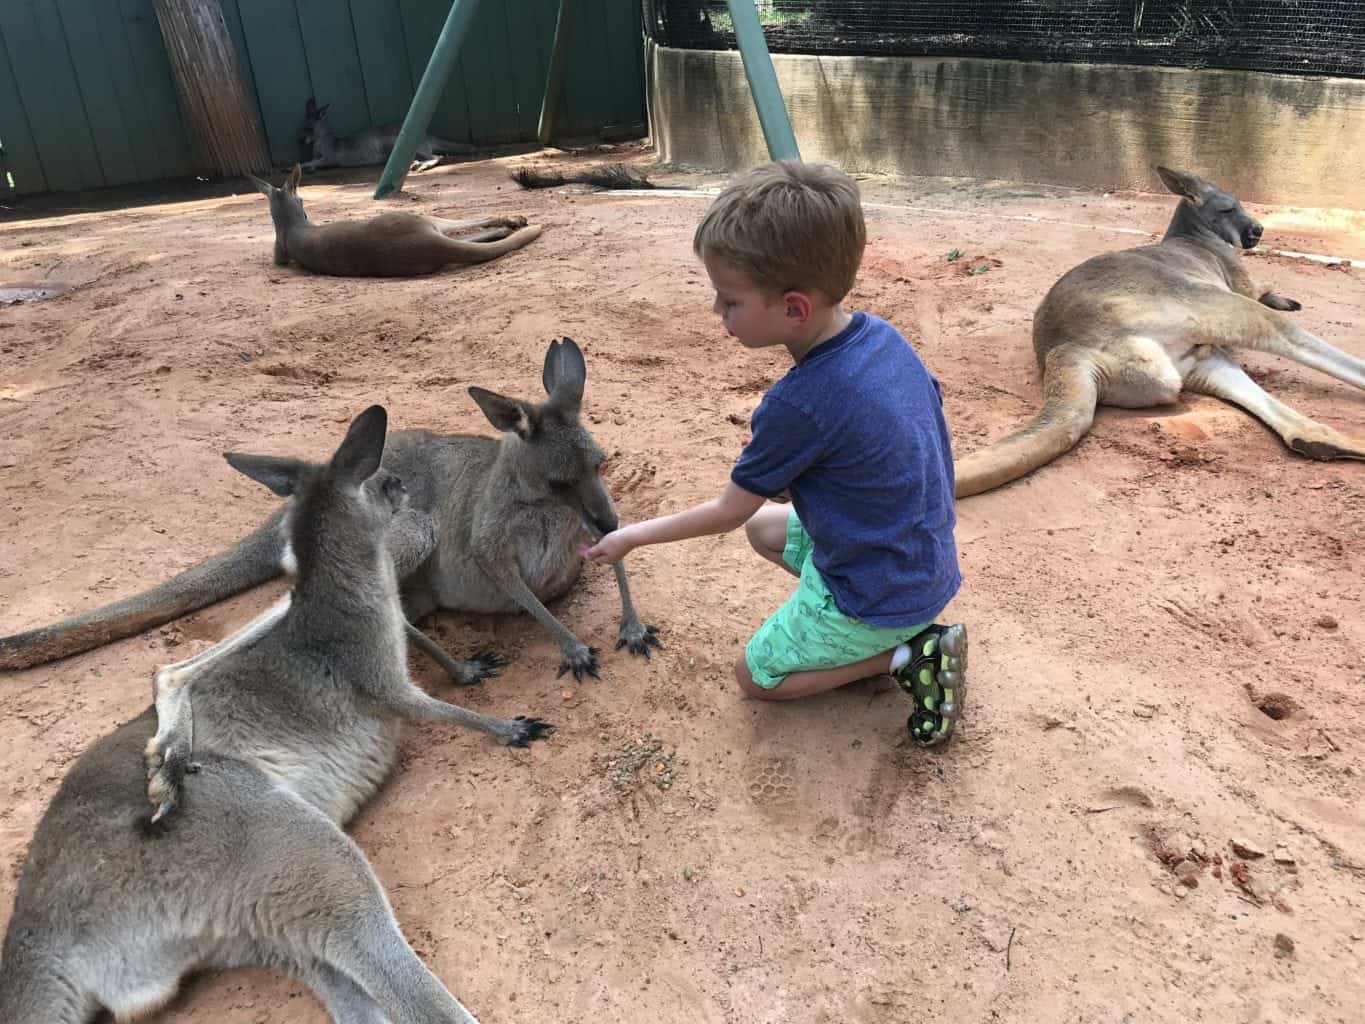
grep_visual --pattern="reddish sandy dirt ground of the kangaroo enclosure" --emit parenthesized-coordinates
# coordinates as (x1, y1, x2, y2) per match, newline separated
(0, 152, 1365, 1024)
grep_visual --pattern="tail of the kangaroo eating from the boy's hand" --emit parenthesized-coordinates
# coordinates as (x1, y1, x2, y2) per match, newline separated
(0, 509, 284, 672)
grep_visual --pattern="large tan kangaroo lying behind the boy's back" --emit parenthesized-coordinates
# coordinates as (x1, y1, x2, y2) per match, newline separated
(956, 167, 1365, 497)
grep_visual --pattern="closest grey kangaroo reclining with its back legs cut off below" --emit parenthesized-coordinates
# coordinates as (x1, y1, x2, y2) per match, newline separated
(0, 406, 547, 1024)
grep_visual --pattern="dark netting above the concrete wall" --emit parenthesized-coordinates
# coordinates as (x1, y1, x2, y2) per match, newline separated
(644, 0, 1365, 78)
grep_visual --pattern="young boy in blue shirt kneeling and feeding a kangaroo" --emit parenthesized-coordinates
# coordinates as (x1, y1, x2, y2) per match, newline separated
(586, 161, 966, 747)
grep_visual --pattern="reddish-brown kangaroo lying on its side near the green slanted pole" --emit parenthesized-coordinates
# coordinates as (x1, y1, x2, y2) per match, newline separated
(251, 164, 541, 277)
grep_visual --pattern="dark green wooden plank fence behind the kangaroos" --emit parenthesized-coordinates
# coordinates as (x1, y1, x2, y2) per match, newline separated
(0, 0, 644, 194)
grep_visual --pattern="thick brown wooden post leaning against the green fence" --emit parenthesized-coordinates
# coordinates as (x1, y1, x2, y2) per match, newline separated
(153, 0, 270, 176)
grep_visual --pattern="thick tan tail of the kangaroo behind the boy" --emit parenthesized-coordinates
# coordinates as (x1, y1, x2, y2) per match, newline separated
(954, 347, 1099, 498)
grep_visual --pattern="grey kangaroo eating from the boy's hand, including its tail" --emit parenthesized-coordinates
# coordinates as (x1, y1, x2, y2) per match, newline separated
(0, 339, 662, 684)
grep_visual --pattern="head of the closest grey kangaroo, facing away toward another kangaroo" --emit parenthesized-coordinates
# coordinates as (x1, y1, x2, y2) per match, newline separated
(224, 406, 408, 583)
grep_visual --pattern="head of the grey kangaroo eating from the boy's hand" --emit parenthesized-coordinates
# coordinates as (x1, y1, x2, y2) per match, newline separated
(470, 337, 617, 537)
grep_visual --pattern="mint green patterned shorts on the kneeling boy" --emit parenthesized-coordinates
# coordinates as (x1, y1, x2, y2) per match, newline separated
(744, 509, 930, 689)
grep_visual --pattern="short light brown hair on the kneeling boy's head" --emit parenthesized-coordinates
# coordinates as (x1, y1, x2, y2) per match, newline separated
(692, 160, 867, 303)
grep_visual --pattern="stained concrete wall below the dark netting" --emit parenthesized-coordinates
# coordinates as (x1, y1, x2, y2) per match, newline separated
(648, 46, 1365, 209)
